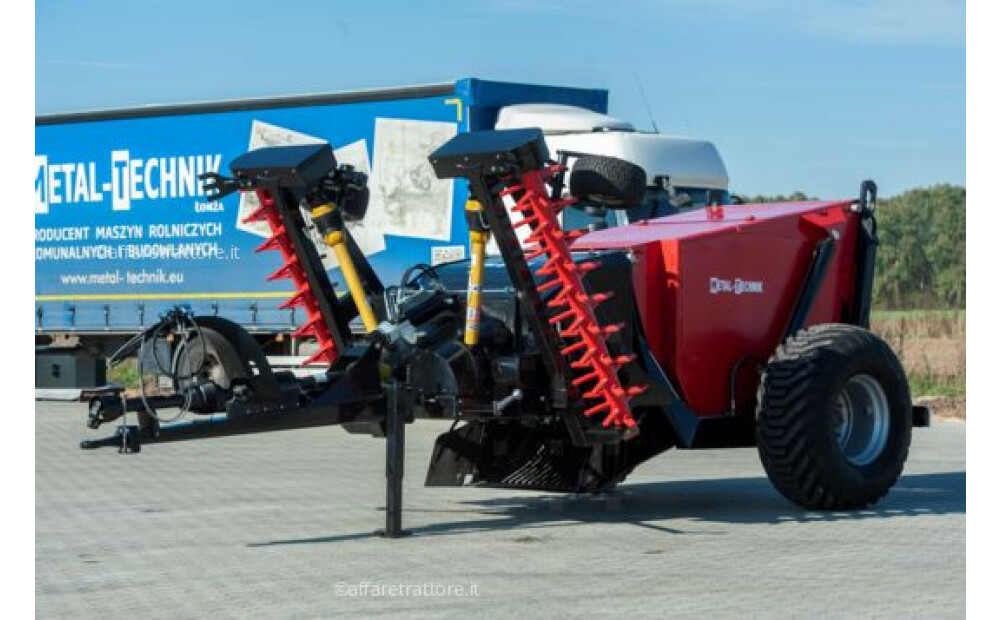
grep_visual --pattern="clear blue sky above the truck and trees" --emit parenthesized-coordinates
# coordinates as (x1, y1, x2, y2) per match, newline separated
(35, 0, 965, 197)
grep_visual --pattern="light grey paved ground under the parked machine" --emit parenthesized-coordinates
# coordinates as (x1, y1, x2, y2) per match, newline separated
(35, 402, 965, 618)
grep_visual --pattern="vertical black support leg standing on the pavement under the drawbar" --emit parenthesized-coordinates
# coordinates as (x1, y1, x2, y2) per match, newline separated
(375, 378, 413, 538)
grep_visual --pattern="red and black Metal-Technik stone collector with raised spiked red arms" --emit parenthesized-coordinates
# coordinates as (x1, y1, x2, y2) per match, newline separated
(81, 129, 929, 536)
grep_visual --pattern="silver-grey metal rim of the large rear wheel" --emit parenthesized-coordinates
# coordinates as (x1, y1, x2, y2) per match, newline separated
(833, 375, 889, 466)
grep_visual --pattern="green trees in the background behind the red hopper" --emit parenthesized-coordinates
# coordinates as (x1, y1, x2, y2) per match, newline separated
(738, 184, 965, 310)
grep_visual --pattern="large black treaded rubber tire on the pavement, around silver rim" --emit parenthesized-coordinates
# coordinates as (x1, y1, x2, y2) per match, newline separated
(757, 324, 913, 510)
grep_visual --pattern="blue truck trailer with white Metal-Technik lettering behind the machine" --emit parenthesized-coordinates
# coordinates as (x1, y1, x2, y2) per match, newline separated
(35, 79, 608, 356)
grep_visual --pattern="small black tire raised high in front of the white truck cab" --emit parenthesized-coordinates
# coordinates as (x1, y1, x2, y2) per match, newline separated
(569, 155, 646, 209)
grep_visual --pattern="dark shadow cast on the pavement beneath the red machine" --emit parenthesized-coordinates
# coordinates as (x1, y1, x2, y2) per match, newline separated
(248, 471, 965, 547)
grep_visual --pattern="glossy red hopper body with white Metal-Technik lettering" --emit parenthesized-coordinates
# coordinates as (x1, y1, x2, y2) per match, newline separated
(574, 201, 857, 416)
